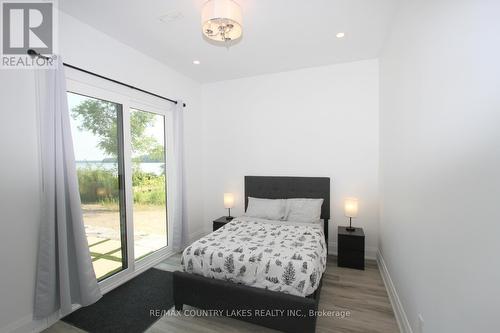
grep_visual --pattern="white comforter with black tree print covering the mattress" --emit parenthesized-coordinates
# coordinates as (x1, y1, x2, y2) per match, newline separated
(181, 217, 326, 296)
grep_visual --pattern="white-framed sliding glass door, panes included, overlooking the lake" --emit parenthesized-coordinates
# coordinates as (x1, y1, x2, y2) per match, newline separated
(68, 71, 171, 286)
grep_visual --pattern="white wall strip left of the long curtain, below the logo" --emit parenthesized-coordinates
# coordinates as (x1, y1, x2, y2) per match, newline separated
(0, 70, 39, 332)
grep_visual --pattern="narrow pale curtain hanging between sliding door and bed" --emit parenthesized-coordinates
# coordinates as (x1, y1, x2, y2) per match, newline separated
(171, 101, 187, 251)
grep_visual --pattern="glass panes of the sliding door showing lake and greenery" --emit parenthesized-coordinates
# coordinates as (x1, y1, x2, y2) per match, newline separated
(68, 92, 167, 280)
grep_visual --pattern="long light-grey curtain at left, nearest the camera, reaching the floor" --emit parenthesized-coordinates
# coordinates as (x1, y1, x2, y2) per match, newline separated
(34, 60, 101, 319)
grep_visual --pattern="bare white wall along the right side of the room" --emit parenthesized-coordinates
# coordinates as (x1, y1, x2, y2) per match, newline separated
(379, 0, 500, 333)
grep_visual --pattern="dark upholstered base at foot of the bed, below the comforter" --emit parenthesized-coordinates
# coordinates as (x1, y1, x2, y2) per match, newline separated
(173, 271, 321, 333)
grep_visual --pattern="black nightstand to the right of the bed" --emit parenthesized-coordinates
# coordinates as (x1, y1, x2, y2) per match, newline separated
(337, 227, 365, 269)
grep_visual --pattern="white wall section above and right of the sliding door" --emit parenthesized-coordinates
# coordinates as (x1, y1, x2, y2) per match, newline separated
(60, 14, 202, 241)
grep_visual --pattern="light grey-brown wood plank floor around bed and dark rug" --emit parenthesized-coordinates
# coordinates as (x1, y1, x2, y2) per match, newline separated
(44, 255, 399, 333)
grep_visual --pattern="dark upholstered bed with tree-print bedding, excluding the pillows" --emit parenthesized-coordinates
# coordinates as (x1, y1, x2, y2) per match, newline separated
(173, 176, 330, 332)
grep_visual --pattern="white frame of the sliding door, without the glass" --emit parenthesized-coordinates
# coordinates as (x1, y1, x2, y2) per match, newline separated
(66, 69, 175, 293)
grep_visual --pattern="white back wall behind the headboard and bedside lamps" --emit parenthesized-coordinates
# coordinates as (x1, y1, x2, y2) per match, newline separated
(202, 60, 379, 256)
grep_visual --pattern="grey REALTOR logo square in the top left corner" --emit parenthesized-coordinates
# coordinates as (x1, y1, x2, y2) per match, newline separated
(1, 0, 55, 68)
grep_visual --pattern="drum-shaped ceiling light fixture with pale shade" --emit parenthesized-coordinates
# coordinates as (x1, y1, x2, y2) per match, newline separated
(201, 0, 243, 44)
